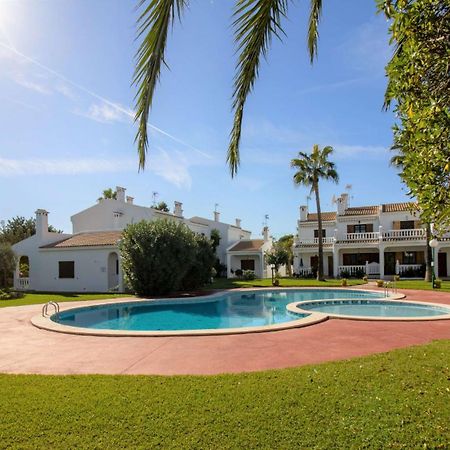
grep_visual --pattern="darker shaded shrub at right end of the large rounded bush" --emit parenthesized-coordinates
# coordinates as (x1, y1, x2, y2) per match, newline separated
(181, 235, 216, 289)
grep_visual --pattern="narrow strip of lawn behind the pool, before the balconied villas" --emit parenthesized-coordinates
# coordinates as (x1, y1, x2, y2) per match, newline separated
(205, 278, 365, 289)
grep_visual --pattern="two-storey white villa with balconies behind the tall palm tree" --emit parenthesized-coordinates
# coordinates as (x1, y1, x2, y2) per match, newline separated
(294, 194, 450, 279)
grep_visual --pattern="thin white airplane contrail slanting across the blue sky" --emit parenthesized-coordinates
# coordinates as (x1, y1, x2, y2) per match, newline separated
(0, 42, 212, 159)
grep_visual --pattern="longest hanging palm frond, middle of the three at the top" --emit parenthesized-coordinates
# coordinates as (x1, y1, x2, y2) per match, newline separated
(227, 0, 288, 177)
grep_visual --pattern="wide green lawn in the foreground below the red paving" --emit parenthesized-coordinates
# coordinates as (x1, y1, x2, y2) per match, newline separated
(0, 341, 450, 449)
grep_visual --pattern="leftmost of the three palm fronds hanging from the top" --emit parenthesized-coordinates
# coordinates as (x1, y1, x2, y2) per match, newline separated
(133, 0, 188, 169)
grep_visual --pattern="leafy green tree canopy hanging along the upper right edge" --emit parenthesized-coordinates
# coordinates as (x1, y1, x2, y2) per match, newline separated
(378, 0, 450, 228)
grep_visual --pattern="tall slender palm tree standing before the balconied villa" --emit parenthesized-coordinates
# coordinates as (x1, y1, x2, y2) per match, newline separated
(291, 144, 339, 281)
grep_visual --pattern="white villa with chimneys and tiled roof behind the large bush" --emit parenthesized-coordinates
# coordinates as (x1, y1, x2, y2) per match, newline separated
(13, 187, 271, 292)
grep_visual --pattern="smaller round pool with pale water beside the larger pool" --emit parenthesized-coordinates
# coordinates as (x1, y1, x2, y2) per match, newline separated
(296, 299, 450, 319)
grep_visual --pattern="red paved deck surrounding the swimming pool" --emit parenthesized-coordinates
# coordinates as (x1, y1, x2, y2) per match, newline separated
(0, 290, 450, 375)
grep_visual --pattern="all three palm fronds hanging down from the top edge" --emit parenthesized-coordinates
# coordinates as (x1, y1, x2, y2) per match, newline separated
(133, 0, 322, 176)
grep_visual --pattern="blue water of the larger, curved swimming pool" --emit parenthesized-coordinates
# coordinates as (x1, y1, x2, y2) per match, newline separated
(52, 289, 380, 331)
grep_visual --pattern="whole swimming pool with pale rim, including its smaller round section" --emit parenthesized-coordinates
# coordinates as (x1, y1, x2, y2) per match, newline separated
(31, 288, 450, 336)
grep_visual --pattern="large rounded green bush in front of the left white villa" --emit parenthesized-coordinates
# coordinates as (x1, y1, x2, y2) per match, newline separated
(120, 219, 214, 296)
